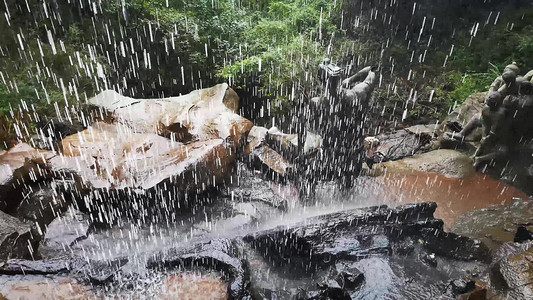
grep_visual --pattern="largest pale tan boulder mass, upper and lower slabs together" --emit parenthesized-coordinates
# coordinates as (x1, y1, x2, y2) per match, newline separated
(51, 84, 253, 191)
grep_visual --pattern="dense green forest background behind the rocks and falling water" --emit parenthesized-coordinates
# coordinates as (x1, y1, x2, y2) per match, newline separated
(0, 0, 533, 147)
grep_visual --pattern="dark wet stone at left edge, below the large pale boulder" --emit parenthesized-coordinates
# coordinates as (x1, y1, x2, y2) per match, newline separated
(0, 211, 39, 262)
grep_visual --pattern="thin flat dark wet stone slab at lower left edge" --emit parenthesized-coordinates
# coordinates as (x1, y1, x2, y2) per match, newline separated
(0, 259, 70, 275)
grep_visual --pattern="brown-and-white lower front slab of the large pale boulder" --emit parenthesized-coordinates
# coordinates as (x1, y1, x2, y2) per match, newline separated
(55, 123, 236, 189)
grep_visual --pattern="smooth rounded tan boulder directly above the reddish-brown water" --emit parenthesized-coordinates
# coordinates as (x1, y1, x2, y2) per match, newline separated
(376, 149, 475, 179)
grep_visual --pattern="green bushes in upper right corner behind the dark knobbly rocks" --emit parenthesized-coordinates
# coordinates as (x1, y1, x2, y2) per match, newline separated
(433, 9, 533, 108)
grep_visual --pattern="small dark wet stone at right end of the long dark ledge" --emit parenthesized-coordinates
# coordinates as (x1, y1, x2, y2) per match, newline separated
(421, 228, 491, 262)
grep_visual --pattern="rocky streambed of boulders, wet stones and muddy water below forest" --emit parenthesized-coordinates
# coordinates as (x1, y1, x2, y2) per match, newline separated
(0, 85, 533, 299)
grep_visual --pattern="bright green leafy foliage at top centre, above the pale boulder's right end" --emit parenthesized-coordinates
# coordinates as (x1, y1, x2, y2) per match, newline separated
(217, 0, 338, 111)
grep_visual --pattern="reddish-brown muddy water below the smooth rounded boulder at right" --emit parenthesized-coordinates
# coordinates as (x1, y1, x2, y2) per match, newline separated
(377, 172, 527, 228)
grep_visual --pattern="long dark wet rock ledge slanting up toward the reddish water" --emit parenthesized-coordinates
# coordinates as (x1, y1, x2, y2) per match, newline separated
(244, 203, 442, 270)
